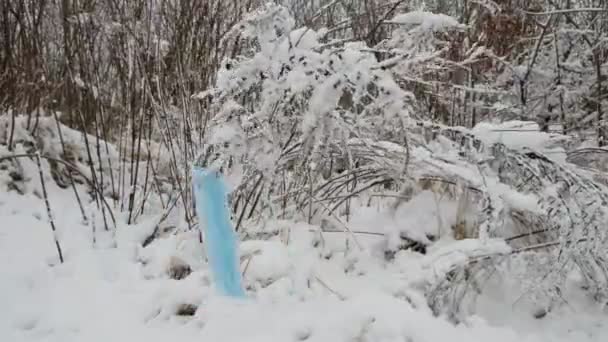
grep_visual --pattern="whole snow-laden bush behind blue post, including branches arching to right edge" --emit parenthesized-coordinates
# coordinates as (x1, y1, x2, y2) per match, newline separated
(194, 5, 608, 315)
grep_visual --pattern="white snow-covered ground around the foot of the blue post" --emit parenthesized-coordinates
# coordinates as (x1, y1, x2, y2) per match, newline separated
(0, 176, 608, 342)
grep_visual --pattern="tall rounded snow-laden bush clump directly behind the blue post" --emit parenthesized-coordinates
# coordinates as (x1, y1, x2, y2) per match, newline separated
(204, 4, 412, 226)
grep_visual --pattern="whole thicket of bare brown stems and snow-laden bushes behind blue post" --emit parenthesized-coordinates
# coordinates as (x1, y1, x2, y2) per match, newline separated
(0, 0, 608, 320)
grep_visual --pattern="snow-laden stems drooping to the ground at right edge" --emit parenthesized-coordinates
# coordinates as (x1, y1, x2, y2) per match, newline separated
(412, 122, 608, 318)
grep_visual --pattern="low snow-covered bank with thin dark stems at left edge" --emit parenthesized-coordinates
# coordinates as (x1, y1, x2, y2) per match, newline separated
(0, 113, 177, 229)
